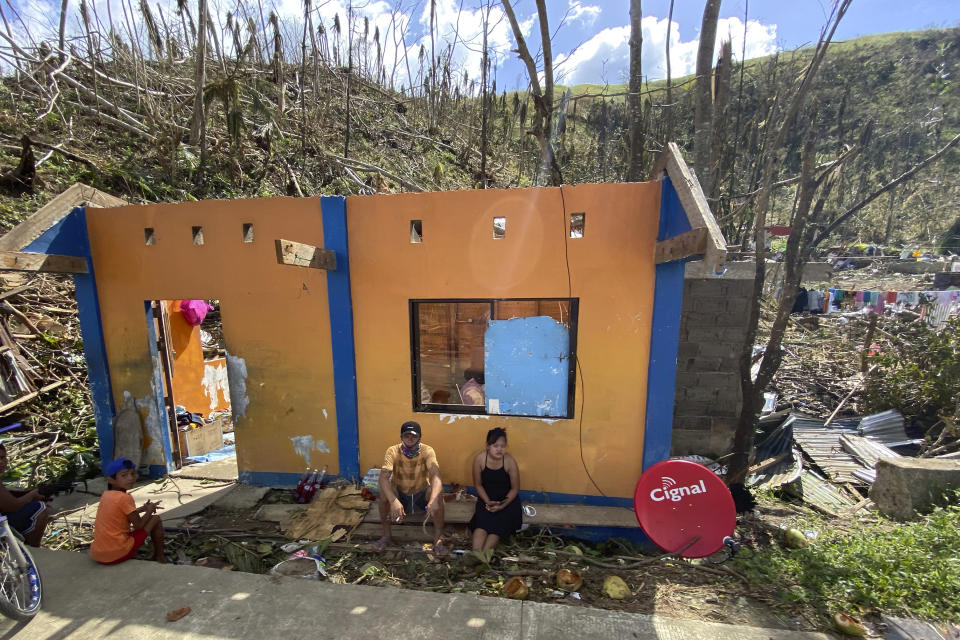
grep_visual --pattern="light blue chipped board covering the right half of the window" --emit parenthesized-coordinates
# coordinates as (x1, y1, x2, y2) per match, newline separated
(483, 316, 570, 418)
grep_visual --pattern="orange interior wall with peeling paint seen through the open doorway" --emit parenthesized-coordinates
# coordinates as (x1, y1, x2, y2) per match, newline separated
(163, 300, 230, 416)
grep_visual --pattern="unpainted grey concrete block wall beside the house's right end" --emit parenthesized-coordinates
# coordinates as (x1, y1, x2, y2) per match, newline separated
(671, 270, 753, 458)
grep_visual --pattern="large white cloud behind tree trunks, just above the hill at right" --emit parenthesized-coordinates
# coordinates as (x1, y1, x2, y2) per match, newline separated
(554, 16, 777, 85)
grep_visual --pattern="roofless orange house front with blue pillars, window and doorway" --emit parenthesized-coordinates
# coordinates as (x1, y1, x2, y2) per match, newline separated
(4, 145, 724, 506)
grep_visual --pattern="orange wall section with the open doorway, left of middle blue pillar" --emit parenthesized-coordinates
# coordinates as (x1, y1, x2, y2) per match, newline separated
(87, 198, 339, 473)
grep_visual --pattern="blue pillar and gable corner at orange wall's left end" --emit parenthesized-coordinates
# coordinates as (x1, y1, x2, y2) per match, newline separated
(23, 207, 116, 472)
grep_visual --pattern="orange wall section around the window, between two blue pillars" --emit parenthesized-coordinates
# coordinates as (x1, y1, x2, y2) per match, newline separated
(347, 182, 664, 497)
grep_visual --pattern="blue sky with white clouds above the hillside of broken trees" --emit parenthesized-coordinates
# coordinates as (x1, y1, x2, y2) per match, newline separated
(7, 0, 960, 89)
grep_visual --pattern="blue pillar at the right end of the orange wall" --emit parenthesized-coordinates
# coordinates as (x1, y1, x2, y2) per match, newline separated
(643, 178, 690, 470)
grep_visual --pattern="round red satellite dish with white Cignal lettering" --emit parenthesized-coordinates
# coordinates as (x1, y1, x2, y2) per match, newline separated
(633, 460, 737, 558)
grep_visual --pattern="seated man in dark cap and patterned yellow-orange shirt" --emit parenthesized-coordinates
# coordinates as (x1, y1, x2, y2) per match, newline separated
(373, 421, 447, 556)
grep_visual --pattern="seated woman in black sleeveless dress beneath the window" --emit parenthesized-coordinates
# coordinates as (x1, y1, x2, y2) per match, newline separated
(467, 427, 523, 551)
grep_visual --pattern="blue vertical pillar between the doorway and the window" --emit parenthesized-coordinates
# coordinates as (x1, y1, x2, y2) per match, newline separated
(320, 196, 360, 484)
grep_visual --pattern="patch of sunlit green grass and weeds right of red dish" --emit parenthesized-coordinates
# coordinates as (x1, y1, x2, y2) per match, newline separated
(733, 505, 960, 620)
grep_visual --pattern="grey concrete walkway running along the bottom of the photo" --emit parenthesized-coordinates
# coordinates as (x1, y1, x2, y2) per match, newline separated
(0, 549, 829, 640)
